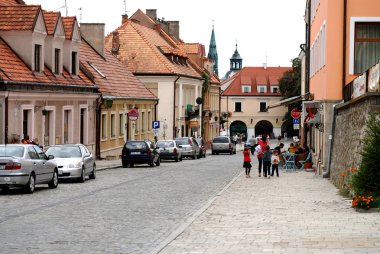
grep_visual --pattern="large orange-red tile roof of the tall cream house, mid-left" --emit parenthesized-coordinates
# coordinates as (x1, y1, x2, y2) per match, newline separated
(105, 21, 201, 79)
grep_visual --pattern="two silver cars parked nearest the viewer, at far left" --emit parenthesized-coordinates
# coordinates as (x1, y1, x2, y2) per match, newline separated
(0, 144, 96, 193)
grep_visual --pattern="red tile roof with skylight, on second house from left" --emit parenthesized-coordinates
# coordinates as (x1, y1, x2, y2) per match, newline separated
(80, 39, 156, 99)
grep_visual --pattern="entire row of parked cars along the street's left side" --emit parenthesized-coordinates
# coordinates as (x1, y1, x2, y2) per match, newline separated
(0, 136, 236, 193)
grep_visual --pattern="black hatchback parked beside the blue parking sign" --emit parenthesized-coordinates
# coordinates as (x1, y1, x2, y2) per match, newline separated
(121, 140, 161, 168)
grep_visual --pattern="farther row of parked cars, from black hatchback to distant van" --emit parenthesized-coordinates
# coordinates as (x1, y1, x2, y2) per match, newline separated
(121, 136, 236, 168)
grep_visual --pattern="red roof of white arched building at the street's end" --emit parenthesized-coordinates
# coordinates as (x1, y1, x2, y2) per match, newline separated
(221, 67, 292, 96)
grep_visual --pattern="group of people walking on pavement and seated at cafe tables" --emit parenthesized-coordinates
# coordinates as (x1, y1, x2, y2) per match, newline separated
(243, 135, 309, 179)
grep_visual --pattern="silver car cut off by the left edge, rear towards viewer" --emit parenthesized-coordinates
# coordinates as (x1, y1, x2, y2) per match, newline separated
(0, 144, 58, 193)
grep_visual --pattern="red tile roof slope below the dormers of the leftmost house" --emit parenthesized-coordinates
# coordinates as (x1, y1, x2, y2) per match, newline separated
(0, 37, 94, 86)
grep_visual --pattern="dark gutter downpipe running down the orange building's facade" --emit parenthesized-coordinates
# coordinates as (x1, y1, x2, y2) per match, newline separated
(323, 0, 347, 178)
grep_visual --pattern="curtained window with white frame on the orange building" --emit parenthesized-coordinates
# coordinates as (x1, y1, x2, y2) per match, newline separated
(354, 22, 380, 73)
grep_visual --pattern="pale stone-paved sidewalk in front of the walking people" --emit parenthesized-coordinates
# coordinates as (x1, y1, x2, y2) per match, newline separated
(160, 148, 380, 254)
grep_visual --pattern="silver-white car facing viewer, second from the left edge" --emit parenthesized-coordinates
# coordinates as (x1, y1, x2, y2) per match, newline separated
(46, 144, 96, 183)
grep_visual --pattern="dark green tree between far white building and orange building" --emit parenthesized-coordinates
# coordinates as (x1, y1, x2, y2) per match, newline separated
(278, 58, 302, 135)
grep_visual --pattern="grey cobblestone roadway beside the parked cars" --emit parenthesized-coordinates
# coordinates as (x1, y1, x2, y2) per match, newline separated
(0, 151, 242, 254)
